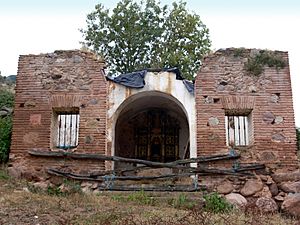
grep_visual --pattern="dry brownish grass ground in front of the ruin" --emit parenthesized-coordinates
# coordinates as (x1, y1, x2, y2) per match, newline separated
(0, 170, 297, 225)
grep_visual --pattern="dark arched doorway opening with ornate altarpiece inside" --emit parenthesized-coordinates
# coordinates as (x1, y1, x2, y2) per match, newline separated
(114, 92, 190, 168)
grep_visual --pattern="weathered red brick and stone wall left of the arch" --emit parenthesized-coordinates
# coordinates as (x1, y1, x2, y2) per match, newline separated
(10, 50, 107, 179)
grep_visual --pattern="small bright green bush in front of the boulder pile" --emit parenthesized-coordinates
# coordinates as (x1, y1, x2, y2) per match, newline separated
(204, 192, 233, 213)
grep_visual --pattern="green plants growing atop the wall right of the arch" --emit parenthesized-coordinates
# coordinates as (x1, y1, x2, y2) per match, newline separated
(245, 50, 286, 76)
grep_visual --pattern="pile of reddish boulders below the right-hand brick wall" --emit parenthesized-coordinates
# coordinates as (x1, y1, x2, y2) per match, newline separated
(215, 170, 300, 218)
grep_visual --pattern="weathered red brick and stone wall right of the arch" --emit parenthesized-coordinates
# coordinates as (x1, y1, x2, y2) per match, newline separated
(195, 49, 297, 169)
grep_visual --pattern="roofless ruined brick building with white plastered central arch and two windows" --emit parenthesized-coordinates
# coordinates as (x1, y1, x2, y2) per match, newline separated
(10, 49, 297, 180)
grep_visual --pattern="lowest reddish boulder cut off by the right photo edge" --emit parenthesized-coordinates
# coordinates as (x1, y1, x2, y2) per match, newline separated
(281, 194, 300, 218)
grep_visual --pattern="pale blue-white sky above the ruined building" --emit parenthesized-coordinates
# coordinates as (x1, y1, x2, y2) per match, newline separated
(0, 0, 300, 127)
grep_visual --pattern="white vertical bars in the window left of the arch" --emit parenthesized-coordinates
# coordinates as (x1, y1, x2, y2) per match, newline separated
(57, 113, 79, 149)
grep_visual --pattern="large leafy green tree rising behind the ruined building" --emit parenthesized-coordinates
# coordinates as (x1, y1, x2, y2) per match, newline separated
(81, 0, 211, 79)
